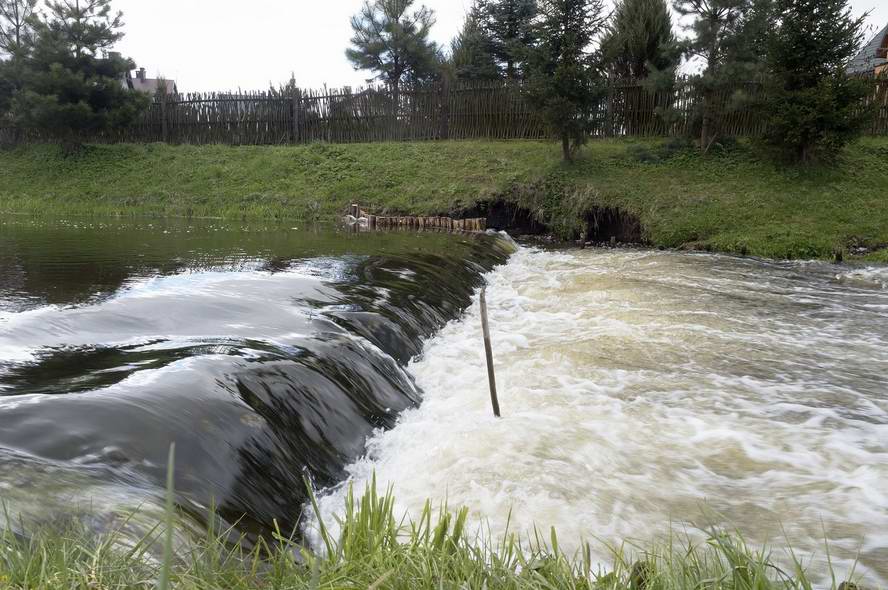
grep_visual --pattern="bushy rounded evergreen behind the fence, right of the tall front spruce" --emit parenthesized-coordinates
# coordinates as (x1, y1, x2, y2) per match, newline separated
(601, 0, 681, 80)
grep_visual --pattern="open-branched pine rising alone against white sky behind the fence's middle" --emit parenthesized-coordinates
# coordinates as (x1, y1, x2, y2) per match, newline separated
(345, 0, 440, 93)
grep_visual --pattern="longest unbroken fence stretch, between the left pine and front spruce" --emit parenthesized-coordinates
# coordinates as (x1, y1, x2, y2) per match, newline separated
(114, 83, 547, 145)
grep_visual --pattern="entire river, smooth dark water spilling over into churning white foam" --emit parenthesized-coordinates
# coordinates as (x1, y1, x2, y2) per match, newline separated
(0, 221, 888, 583)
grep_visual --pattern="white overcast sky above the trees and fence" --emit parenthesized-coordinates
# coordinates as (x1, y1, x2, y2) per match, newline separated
(113, 0, 888, 92)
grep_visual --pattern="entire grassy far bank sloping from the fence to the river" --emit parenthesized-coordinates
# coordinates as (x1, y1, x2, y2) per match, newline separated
(0, 138, 888, 260)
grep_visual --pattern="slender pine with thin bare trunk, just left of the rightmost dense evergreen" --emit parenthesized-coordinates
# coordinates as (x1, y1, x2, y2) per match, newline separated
(673, 0, 753, 152)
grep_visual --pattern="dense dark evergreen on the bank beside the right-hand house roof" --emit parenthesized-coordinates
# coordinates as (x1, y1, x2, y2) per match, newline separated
(766, 0, 867, 163)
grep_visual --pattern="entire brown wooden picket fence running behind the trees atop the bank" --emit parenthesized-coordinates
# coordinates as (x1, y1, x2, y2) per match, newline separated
(0, 78, 888, 145)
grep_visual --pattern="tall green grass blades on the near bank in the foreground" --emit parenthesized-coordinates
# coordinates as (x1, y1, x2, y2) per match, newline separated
(0, 474, 853, 590)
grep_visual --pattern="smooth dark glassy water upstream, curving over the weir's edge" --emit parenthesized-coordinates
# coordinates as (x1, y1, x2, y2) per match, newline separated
(0, 221, 511, 533)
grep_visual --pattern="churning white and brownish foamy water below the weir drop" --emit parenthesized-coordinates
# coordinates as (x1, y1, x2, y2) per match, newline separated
(322, 249, 888, 583)
